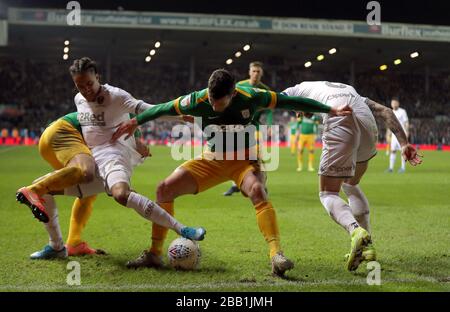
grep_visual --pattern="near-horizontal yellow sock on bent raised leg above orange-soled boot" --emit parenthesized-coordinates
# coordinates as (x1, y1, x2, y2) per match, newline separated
(28, 167, 83, 196)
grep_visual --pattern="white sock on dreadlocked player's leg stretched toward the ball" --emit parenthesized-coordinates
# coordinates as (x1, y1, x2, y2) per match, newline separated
(127, 192, 184, 234)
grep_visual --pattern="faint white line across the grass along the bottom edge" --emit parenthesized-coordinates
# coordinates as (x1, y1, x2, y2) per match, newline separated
(0, 276, 439, 291)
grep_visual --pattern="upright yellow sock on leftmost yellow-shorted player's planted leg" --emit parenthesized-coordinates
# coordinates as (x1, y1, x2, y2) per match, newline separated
(67, 195, 97, 246)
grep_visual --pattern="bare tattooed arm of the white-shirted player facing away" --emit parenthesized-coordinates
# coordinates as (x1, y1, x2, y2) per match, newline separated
(366, 99, 423, 166)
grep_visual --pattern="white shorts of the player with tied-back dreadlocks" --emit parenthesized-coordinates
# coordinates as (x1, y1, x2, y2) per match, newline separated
(92, 143, 143, 191)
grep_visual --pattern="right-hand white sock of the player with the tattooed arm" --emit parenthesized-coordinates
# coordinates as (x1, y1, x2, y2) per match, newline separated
(342, 183, 370, 233)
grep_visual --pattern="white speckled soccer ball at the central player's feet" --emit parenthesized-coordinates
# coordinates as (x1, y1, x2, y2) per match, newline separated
(167, 237, 201, 270)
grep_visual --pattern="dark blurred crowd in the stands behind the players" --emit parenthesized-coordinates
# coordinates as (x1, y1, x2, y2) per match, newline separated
(0, 58, 450, 144)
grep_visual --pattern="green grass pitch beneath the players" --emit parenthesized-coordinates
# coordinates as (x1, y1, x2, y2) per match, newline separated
(0, 147, 450, 291)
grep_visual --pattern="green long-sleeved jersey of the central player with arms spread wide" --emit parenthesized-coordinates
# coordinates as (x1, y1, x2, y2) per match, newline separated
(136, 86, 330, 151)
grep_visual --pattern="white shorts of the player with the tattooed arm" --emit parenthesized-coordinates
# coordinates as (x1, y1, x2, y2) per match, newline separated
(319, 104, 378, 178)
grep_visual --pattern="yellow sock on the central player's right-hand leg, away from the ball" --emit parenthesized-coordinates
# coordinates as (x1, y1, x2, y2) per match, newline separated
(255, 201, 281, 258)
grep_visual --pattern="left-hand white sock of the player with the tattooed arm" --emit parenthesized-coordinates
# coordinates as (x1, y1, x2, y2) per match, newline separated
(319, 192, 359, 234)
